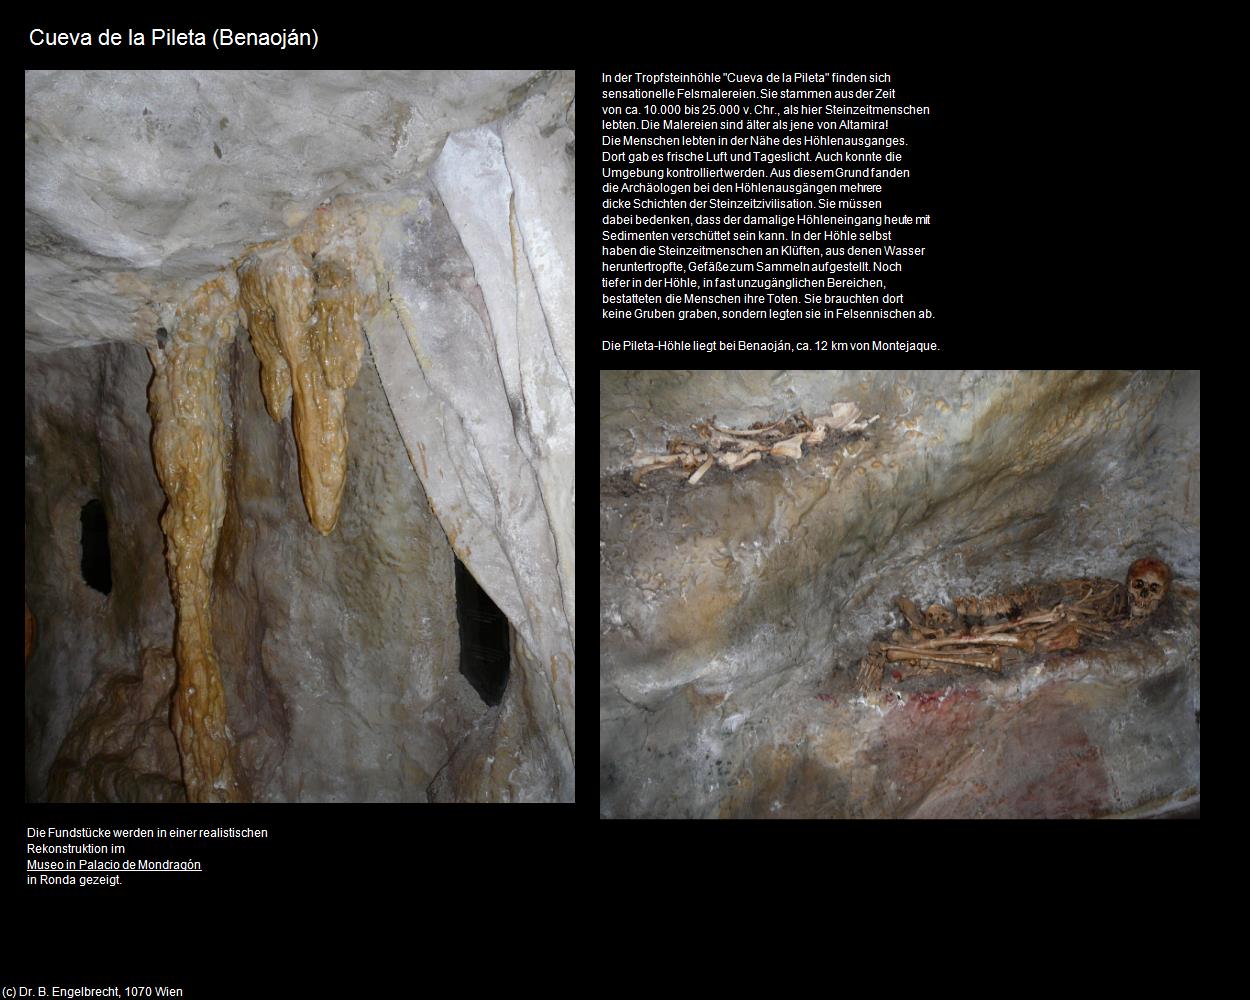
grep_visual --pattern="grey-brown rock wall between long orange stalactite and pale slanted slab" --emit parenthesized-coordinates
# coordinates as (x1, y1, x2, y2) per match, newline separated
(214, 327, 472, 801)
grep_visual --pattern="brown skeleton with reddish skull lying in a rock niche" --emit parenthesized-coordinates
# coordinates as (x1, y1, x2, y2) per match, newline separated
(858, 559, 1171, 691)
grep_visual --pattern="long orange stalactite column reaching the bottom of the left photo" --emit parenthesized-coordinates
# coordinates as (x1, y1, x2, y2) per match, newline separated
(148, 275, 244, 803)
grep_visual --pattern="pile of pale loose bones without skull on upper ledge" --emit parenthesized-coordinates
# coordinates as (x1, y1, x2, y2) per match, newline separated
(630, 403, 878, 486)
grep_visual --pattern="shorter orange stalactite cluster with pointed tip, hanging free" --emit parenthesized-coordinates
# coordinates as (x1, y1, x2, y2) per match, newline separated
(238, 245, 364, 535)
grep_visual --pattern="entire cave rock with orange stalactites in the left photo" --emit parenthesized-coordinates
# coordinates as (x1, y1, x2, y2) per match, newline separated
(26, 73, 575, 801)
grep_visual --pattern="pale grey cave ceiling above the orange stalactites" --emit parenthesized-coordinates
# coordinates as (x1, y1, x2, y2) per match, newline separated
(25, 70, 541, 350)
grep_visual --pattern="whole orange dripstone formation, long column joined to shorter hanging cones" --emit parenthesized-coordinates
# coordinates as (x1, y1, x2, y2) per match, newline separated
(140, 212, 364, 801)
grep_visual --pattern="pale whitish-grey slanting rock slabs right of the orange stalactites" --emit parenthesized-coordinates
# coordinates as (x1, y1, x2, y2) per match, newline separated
(366, 75, 576, 800)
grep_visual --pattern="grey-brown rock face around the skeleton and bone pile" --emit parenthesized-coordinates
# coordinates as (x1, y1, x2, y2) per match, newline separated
(600, 371, 1200, 818)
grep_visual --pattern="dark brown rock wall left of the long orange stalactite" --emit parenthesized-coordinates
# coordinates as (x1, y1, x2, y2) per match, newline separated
(25, 344, 180, 800)
